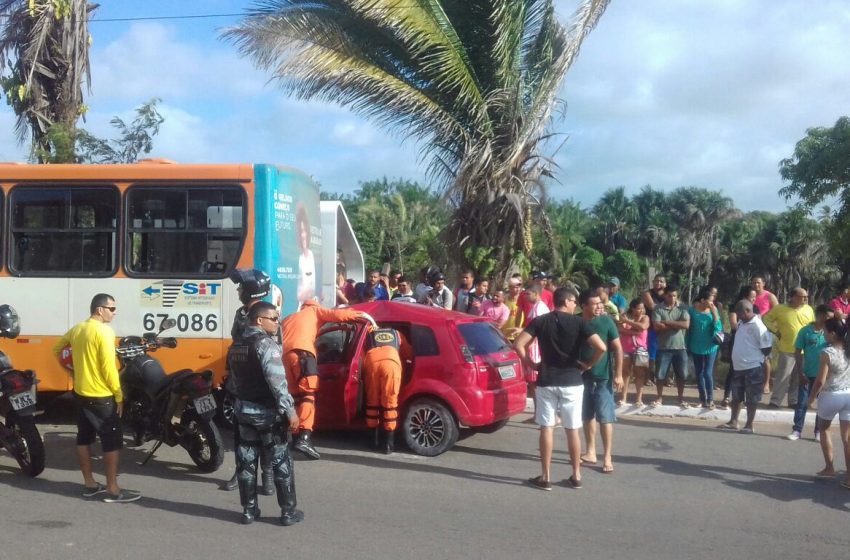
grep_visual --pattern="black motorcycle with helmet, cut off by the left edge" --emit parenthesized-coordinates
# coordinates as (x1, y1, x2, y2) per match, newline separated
(0, 305, 44, 477)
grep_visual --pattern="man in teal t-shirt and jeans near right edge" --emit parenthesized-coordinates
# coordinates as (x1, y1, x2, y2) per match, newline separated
(785, 305, 833, 441)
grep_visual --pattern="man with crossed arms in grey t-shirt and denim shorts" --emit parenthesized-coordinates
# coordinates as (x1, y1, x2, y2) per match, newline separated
(652, 284, 691, 408)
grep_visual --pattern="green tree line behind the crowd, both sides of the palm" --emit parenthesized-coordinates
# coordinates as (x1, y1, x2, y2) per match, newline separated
(336, 179, 846, 301)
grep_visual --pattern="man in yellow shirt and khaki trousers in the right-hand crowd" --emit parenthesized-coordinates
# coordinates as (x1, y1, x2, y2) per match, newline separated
(763, 288, 815, 408)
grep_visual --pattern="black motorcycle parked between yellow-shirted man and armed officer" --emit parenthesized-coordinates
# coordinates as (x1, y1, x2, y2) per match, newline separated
(116, 318, 224, 472)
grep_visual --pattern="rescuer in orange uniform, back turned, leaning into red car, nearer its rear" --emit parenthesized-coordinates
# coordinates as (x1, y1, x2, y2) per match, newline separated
(363, 328, 412, 455)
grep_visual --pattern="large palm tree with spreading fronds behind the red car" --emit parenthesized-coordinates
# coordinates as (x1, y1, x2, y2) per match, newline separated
(224, 0, 609, 269)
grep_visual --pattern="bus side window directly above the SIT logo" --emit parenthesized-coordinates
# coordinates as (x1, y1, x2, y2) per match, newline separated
(126, 185, 245, 276)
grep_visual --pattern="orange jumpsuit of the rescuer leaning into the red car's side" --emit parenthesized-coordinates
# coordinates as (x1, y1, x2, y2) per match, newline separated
(363, 331, 413, 432)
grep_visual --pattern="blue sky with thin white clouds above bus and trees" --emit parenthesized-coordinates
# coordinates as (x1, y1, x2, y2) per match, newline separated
(0, 0, 850, 211)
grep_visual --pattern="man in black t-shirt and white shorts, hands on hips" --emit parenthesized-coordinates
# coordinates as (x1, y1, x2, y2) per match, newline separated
(514, 288, 606, 490)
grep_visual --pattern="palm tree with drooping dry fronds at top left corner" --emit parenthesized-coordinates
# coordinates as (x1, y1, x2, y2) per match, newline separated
(0, 0, 97, 161)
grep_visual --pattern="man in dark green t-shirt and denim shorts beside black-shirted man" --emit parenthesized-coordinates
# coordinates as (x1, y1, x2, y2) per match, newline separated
(579, 290, 623, 474)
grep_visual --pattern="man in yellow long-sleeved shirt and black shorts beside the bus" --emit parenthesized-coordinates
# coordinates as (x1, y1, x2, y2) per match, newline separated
(53, 294, 141, 503)
